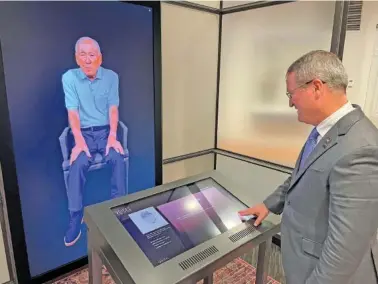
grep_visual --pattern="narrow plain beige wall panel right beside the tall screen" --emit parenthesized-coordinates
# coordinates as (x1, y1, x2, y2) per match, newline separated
(161, 3, 219, 159)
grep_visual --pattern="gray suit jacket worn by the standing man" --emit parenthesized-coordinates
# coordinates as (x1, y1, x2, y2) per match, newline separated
(264, 106, 378, 284)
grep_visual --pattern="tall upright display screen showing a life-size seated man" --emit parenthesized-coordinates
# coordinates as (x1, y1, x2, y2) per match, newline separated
(0, 1, 160, 277)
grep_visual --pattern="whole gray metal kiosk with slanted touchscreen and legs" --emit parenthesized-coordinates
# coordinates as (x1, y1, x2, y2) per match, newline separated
(84, 171, 279, 284)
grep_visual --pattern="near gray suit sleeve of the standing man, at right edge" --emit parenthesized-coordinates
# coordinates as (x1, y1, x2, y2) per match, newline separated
(306, 147, 378, 284)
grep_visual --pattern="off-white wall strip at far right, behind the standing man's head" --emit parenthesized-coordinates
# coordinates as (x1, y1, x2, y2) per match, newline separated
(343, 1, 378, 123)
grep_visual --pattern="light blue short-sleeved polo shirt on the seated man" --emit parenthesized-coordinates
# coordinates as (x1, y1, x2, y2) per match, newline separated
(62, 67, 119, 128)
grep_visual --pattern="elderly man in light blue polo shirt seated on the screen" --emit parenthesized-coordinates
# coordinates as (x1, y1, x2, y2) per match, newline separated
(62, 37, 126, 246)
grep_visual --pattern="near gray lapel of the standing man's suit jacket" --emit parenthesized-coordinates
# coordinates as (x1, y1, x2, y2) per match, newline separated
(289, 105, 364, 191)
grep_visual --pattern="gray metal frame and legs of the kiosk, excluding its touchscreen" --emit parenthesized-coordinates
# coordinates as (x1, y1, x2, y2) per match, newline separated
(84, 171, 279, 284)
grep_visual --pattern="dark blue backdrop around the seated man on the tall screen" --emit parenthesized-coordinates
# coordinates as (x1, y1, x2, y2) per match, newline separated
(0, 2, 155, 276)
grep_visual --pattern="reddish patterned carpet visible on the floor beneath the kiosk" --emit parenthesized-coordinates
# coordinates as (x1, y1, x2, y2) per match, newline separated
(53, 258, 280, 284)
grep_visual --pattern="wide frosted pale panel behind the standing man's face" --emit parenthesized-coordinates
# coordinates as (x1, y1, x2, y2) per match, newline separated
(218, 1, 335, 167)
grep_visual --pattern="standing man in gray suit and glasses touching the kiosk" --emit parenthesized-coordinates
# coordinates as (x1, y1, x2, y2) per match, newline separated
(239, 51, 378, 284)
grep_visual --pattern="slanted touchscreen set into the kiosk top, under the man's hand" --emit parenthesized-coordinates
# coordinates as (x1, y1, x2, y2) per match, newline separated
(112, 178, 247, 266)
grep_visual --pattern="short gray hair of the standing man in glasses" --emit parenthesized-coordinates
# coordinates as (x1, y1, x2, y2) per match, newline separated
(287, 50, 348, 90)
